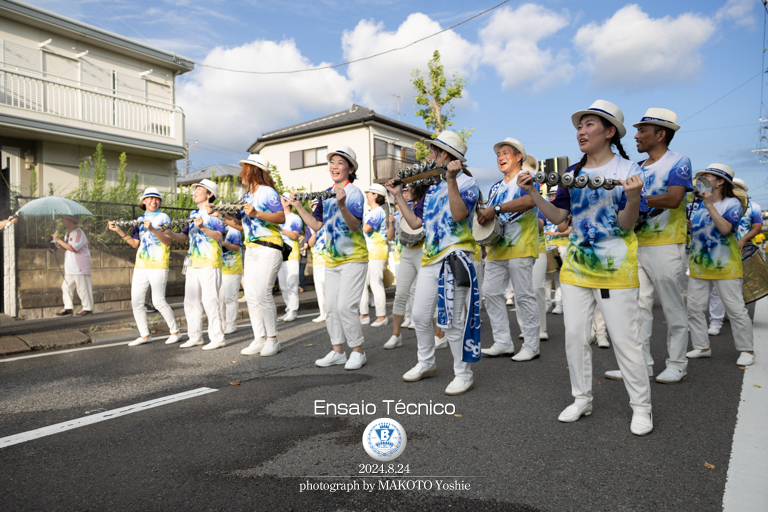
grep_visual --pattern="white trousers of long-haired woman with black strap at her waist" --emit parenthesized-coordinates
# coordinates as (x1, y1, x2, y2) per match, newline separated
(243, 245, 283, 340)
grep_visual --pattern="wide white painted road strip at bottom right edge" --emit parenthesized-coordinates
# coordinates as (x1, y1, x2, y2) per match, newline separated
(724, 298, 768, 512)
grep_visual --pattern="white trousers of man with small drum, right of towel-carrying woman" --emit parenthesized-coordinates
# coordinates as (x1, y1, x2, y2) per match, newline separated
(485, 257, 540, 352)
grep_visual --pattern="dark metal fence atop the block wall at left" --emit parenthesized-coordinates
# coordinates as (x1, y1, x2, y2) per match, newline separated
(14, 196, 193, 249)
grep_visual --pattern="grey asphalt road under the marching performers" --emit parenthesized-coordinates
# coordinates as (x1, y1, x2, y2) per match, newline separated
(0, 300, 742, 512)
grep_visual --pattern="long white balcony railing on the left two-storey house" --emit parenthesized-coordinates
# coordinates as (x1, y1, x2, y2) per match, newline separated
(0, 67, 175, 137)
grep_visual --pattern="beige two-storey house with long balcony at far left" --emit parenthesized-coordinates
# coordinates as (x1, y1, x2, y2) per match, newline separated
(0, 0, 194, 195)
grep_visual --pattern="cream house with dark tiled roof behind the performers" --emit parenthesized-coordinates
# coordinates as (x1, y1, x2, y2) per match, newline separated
(248, 105, 432, 191)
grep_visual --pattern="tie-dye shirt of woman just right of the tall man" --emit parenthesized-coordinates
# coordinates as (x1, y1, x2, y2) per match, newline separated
(688, 197, 742, 279)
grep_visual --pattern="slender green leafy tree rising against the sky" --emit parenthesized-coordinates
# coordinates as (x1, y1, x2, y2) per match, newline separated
(411, 50, 475, 160)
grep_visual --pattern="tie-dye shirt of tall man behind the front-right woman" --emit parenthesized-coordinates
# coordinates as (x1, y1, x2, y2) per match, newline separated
(635, 151, 693, 247)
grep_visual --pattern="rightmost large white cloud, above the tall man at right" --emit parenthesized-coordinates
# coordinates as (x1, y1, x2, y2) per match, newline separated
(574, 4, 716, 87)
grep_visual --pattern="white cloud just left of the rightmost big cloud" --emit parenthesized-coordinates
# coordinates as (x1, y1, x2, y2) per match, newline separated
(480, 4, 573, 90)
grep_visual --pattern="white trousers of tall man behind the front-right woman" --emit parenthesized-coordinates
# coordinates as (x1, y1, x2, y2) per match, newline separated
(637, 244, 688, 371)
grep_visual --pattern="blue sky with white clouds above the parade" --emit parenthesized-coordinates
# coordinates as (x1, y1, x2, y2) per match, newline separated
(24, 0, 768, 208)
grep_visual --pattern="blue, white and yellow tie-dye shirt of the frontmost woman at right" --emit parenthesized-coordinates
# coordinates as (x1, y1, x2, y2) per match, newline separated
(552, 155, 648, 289)
